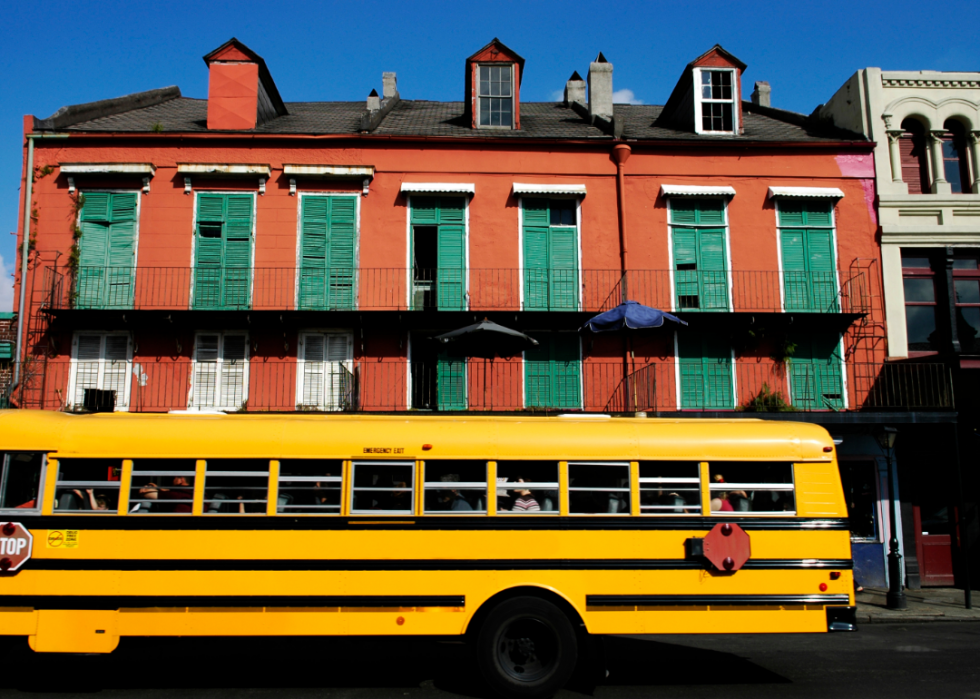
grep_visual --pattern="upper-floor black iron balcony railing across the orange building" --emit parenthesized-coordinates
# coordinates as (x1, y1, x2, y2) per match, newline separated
(33, 266, 871, 313)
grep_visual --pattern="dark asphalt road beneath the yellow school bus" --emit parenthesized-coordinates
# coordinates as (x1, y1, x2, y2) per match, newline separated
(0, 622, 980, 699)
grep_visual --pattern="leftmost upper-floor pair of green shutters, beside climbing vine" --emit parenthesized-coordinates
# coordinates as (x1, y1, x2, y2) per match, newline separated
(76, 192, 137, 308)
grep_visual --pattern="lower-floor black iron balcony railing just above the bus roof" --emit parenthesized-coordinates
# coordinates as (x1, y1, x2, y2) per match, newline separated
(9, 357, 955, 414)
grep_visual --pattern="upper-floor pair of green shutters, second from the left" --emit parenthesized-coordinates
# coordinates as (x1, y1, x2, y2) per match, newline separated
(194, 194, 254, 309)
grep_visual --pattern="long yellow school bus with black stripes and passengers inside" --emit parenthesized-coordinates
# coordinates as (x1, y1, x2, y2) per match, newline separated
(0, 411, 855, 696)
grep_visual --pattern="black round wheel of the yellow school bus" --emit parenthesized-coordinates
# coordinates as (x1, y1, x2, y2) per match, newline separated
(476, 597, 578, 699)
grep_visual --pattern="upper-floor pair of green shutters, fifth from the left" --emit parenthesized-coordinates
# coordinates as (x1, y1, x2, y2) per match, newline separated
(522, 199, 579, 311)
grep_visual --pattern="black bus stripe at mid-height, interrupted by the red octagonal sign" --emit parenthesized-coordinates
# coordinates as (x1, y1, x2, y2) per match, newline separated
(24, 558, 853, 572)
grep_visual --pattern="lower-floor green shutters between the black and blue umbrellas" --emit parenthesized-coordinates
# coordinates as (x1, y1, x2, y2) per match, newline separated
(524, 334, 582, 409)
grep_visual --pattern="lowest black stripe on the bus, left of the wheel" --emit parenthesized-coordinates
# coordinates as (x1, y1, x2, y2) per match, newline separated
(0, 595, 466, 609)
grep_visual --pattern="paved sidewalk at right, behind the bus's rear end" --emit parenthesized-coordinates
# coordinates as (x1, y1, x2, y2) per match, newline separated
(856, 587, 980, 624)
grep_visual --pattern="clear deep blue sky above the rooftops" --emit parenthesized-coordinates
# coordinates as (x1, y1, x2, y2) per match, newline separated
(0, 0, 980, 310)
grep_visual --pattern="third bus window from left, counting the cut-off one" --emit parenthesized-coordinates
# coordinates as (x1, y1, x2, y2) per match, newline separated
(129, 459, 196, 515)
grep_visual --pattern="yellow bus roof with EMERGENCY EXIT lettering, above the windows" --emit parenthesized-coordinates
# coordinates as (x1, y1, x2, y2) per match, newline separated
(0, 410, 833, 461)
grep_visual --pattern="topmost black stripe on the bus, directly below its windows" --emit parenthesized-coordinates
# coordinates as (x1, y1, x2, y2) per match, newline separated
(9, 515, 848, 531)
